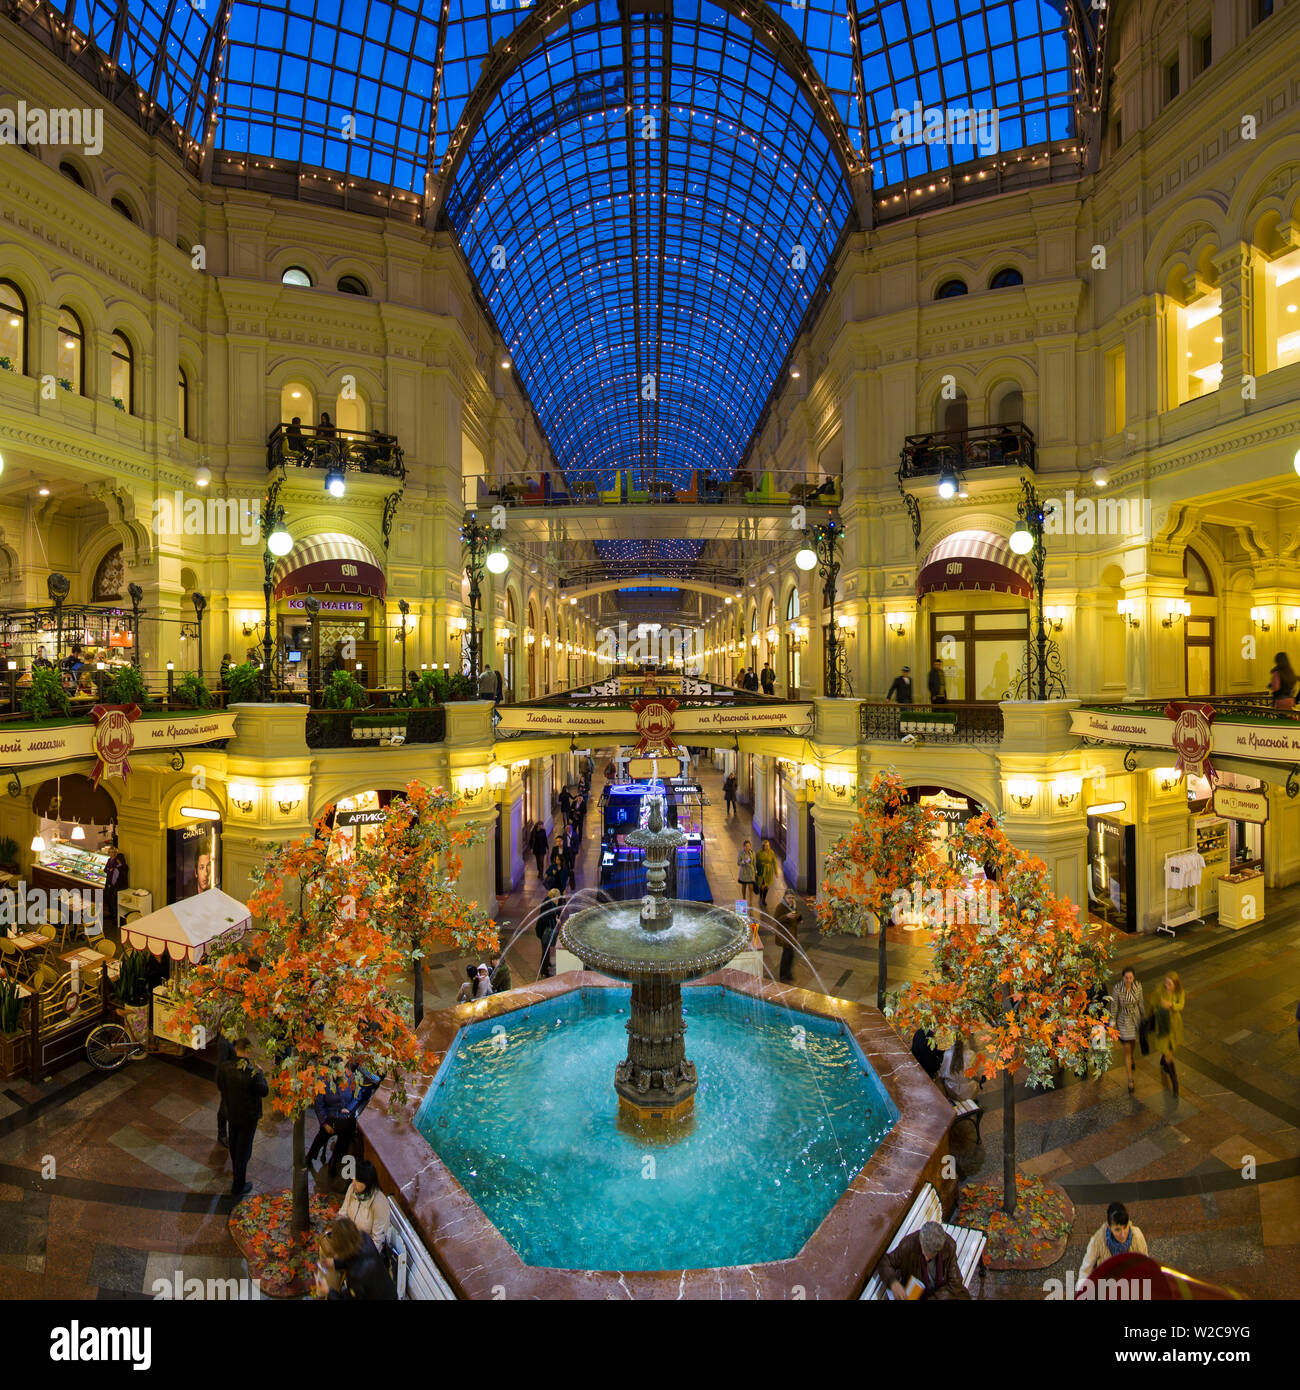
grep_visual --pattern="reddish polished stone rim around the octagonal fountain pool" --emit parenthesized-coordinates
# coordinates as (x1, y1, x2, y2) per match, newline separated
(360, 969, 952, 1300)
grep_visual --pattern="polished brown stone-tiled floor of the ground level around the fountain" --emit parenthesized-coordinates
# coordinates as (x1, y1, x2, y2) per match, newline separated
(0, 770, 1300, 1298)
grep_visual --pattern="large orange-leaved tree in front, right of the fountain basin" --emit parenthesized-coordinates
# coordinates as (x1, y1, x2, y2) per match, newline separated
(894, 815, 1114, 1216)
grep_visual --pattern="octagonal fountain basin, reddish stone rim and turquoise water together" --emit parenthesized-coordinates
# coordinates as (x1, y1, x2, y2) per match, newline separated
(361, 970, 952, 1298)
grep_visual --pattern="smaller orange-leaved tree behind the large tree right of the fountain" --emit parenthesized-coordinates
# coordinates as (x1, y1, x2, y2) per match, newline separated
(818, 771, 955, 1009)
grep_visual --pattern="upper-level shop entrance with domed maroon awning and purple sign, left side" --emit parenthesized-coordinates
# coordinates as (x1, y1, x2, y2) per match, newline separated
(266, 532, 388, 688)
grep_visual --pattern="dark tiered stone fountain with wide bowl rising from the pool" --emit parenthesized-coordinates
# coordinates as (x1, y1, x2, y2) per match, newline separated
(560, 794, 748, 1125)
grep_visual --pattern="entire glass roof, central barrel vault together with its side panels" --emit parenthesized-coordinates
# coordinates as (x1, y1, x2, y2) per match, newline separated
(50, 0, 1084, 487)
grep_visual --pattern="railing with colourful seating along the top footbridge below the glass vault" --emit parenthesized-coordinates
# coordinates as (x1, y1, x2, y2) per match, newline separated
(464, 468, 844, 509)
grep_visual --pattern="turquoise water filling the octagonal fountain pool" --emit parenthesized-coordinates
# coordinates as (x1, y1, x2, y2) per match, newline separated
(416, 986, 898, 1270)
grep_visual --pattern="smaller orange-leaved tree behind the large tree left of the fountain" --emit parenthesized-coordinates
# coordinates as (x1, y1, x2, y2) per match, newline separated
(356, 781, 498, 1026)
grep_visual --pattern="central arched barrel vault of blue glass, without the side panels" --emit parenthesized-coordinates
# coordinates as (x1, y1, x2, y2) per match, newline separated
(446, 0, 851, 488)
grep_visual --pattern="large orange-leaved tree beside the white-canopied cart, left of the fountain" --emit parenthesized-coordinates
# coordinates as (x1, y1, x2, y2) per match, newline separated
(177, 808, 420, 1232)
